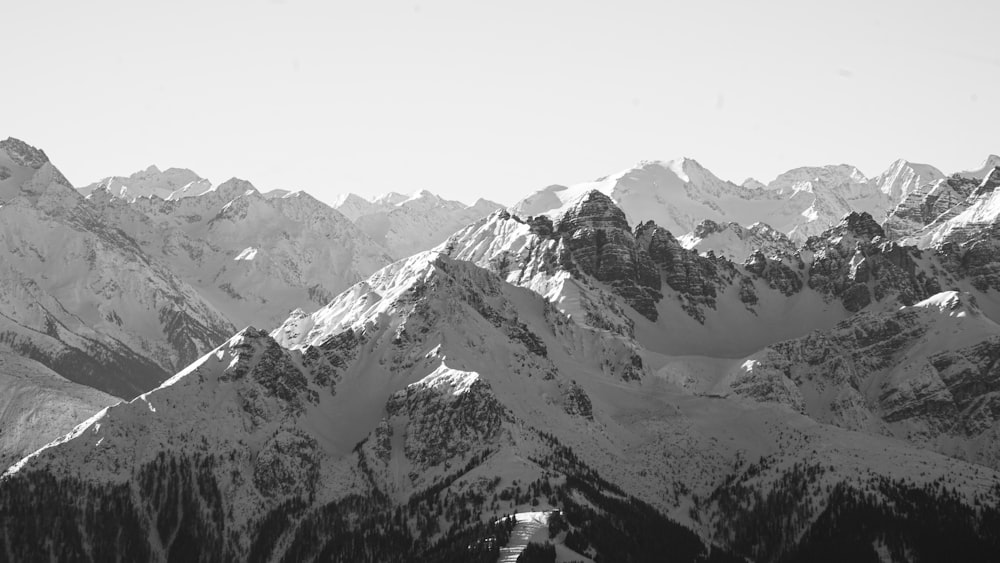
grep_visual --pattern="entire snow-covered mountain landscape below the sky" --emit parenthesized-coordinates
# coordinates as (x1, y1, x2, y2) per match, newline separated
(0, 139, 1000, 563)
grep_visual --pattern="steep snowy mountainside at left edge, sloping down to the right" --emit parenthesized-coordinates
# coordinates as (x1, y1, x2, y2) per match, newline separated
(0, 139, 233, 397)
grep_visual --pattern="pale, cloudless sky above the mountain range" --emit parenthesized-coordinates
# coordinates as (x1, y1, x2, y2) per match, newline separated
(7, 0, 1000, 207)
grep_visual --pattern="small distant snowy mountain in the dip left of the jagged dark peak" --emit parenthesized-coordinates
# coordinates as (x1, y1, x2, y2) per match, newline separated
(334, 190, 501, 258)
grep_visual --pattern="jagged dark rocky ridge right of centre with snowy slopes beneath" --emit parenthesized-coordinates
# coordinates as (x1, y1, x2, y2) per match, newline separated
(450, 190, 952, 357)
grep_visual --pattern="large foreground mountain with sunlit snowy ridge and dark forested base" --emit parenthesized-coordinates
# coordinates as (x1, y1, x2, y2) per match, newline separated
(0, 253, 1000, 561)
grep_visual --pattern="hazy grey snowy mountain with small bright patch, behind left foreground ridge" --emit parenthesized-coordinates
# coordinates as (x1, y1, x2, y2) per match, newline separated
(87, 178, 390, 327)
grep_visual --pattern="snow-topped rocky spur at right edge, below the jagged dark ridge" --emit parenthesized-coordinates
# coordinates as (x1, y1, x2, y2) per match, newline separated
(728, 293, 1000, 466)
